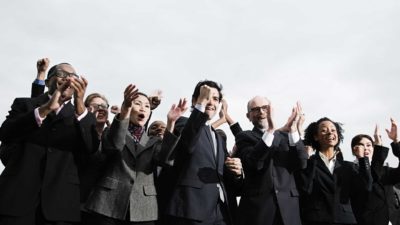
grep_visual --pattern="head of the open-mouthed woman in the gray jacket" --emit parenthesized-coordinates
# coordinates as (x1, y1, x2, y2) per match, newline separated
(130, 92, 150, 127)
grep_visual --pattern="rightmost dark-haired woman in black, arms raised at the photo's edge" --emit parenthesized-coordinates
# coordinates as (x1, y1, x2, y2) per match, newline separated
(351, 119, 400, 225)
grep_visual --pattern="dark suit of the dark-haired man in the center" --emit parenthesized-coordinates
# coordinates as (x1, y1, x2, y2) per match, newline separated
(166, 108, 239, 224)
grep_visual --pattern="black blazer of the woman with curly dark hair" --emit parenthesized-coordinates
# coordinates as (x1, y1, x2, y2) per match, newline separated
(298, 151, 372, 224)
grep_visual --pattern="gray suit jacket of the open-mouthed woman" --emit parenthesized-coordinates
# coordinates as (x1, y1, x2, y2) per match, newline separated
(86, 119, 178, 222)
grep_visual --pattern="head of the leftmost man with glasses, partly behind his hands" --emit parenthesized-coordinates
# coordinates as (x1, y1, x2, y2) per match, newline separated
(45, 63, 79, 99)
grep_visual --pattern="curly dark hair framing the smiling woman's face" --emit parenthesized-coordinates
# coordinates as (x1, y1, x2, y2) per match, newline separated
(304, 117, 344, 151)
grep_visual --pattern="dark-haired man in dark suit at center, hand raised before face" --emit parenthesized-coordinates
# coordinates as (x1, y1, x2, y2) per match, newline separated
(166, 81, 241, 225)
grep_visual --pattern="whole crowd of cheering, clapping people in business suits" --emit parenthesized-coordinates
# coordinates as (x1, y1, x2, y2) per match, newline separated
(0, 58, 400, 225)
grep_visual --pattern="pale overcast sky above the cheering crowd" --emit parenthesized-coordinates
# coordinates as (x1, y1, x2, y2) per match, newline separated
(0, 0, 400, 171)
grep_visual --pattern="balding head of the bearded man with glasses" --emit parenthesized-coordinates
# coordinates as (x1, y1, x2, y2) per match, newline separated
(246, 96, 270, 129)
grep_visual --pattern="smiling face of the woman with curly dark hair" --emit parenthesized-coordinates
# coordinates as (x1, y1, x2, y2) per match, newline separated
(314, 121, 339, 149)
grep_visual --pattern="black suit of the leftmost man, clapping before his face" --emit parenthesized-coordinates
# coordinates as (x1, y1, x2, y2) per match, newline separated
(0, 94, 98, 221)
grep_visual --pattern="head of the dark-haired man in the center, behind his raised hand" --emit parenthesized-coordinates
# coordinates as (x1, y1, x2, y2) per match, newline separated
(192, 80, 222, 120)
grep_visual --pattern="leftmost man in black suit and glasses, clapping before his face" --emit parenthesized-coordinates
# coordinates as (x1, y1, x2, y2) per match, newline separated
(0, 63, 98, 225)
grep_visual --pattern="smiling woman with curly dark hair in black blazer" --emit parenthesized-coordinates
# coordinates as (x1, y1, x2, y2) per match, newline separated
(297, 117, 372, 225)
